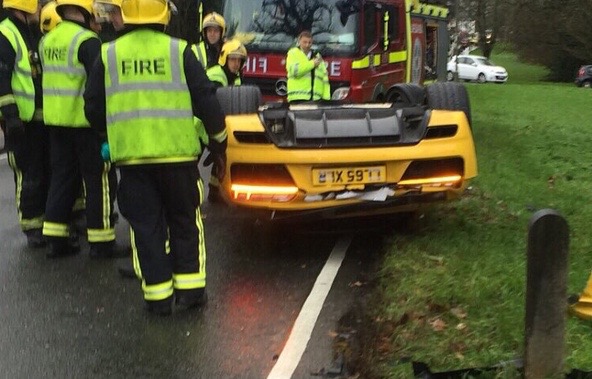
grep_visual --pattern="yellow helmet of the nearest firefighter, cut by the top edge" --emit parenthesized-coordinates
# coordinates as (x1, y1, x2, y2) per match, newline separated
(121, 0, 171, 25)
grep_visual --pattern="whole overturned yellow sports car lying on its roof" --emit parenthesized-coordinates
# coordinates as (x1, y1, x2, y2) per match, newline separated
(218, 83, 477, 219)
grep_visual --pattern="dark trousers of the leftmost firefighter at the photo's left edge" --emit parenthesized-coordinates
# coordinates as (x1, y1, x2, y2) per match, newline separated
(3, 121, 50, 231)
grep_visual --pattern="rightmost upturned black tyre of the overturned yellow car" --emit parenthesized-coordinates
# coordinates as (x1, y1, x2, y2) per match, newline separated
(426, 83, 473, 127)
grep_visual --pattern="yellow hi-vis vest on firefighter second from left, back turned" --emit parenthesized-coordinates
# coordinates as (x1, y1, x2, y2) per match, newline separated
(39, 20, 98, 128)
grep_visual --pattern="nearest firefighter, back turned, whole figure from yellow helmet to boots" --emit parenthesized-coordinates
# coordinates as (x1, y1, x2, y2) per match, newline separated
(84, 0, 226, 316)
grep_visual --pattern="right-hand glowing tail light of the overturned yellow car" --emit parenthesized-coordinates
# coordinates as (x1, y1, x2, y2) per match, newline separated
(397, 158, 464, 187)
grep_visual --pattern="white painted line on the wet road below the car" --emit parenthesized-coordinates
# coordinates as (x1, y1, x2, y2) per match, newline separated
(267, 236, 352, 379)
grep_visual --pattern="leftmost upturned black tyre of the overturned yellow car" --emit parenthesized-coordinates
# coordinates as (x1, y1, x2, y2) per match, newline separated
(216, 85, 262, 115)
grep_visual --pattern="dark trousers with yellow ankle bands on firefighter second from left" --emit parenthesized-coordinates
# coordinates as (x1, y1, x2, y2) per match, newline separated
(43, 126, 117, 244)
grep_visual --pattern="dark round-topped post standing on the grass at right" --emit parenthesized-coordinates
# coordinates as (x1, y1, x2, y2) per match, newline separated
(524, 209, 569, 379)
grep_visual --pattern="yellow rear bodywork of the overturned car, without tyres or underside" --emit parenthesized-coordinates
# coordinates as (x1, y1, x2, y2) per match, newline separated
(222, 105, 477, 220)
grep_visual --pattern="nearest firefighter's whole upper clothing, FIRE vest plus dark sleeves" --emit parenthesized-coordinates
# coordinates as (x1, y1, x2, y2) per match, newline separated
(84, 26, 226, 165)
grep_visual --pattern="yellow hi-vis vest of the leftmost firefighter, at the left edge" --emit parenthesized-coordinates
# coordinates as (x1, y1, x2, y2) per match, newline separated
(0, 18, 35, 122)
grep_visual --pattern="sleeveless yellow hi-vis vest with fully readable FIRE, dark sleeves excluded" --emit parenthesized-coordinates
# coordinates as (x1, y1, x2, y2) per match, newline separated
(101, 29, 203, 165)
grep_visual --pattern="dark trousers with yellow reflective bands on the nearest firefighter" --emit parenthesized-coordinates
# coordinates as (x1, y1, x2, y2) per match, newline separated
(117, 161, 206, 302)
